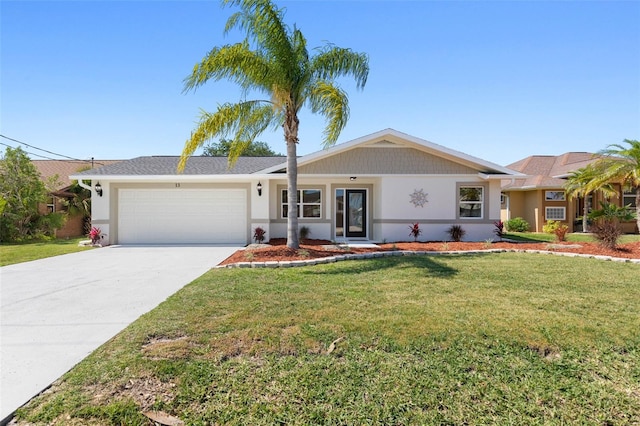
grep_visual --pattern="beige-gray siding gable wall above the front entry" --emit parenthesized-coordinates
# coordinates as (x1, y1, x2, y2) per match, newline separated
(298, 147, 478, 175)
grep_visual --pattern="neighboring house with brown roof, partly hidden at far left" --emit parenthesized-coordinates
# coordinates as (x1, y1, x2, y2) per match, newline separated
(31, 160, 118, 238)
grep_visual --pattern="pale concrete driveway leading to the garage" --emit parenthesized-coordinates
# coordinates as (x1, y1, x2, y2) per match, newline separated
(0, 246, 239, 423)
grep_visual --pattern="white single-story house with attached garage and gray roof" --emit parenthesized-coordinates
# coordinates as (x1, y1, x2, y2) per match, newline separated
(71, 129, 521, 244)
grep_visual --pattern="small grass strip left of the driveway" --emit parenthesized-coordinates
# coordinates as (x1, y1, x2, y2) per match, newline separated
(0, 237, 91, 266)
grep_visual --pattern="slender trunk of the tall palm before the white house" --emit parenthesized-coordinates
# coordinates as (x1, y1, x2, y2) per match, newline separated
(284, 111, 300, 250)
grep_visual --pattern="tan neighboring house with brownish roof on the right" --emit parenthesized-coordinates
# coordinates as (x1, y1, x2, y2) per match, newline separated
(501, 152, 638, 233)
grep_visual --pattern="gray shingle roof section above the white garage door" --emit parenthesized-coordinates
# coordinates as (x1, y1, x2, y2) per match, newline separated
(77, 156, 287, 176)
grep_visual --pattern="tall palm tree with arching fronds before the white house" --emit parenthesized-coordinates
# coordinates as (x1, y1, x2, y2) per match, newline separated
(178, 0, 369, 249)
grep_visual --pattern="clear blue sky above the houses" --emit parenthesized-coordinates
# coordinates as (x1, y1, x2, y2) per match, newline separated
(0, 0, 640, 165)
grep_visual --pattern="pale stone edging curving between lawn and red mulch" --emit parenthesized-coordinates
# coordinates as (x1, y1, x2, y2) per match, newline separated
(216, 249, 640, 268)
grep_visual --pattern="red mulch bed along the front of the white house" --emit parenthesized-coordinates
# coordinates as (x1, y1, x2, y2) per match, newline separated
(220, 238, 640, 265)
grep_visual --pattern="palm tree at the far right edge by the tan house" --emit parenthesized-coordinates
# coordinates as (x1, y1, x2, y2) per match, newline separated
(600, 139, 640, 230)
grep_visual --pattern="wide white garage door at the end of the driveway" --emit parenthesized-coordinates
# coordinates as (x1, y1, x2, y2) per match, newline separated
(118, 188, 247, 244)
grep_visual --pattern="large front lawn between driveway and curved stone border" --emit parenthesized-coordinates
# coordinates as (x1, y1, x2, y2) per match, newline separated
(18, 253, 640, 425)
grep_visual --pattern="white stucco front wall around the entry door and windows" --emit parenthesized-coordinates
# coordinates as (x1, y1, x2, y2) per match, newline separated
(268, 175, 500, 242)
